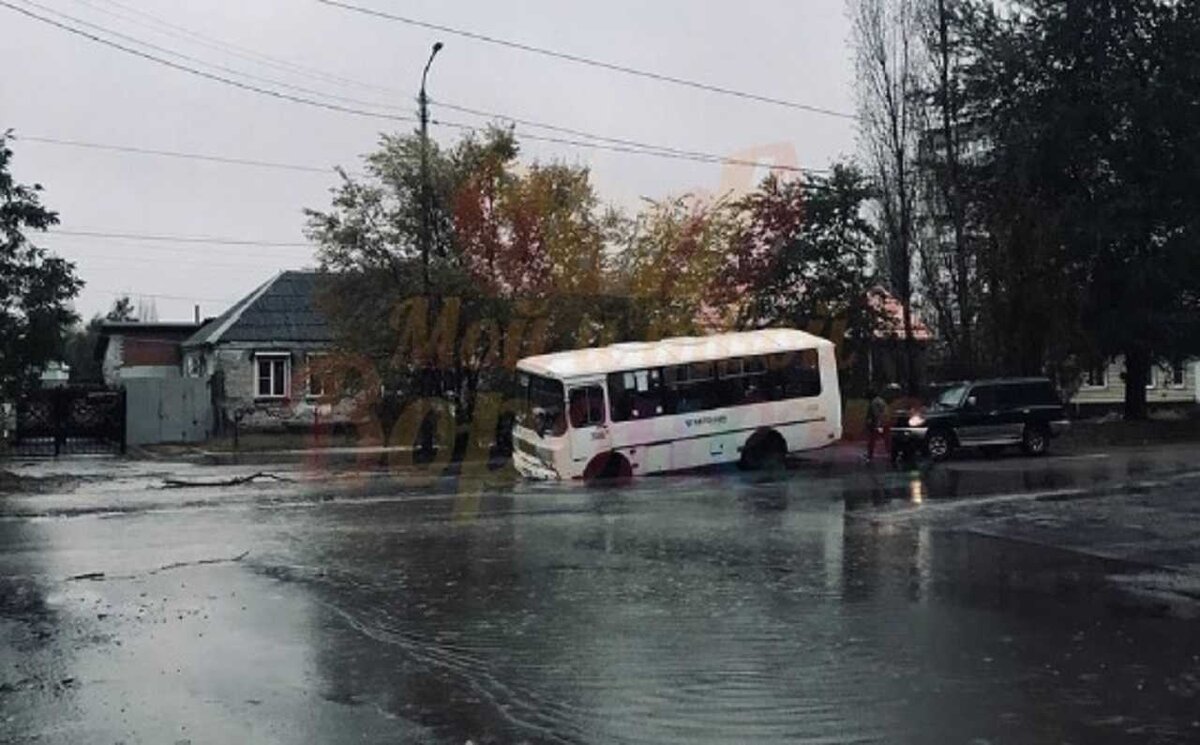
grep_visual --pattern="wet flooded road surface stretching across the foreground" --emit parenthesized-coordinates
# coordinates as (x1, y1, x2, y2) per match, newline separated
(0, 451, 1200, 744)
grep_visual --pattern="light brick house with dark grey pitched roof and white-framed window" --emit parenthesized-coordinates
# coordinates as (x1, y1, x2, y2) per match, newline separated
(182, 271, 340, 431)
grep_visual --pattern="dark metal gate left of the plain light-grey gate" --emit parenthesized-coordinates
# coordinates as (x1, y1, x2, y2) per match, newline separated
(13, 387, 125, 456)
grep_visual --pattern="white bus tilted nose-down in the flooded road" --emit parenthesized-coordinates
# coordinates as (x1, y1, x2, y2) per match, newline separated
(512, 329, 841, 480)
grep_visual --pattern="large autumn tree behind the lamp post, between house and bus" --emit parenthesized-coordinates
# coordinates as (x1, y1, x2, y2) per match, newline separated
(308, 128, 628, 446)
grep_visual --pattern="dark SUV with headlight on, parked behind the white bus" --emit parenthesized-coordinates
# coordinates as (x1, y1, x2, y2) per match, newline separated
(892, 378, 1069, 461)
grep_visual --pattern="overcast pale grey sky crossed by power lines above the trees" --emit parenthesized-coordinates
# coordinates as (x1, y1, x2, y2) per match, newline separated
(0, 0, 854, 320)
